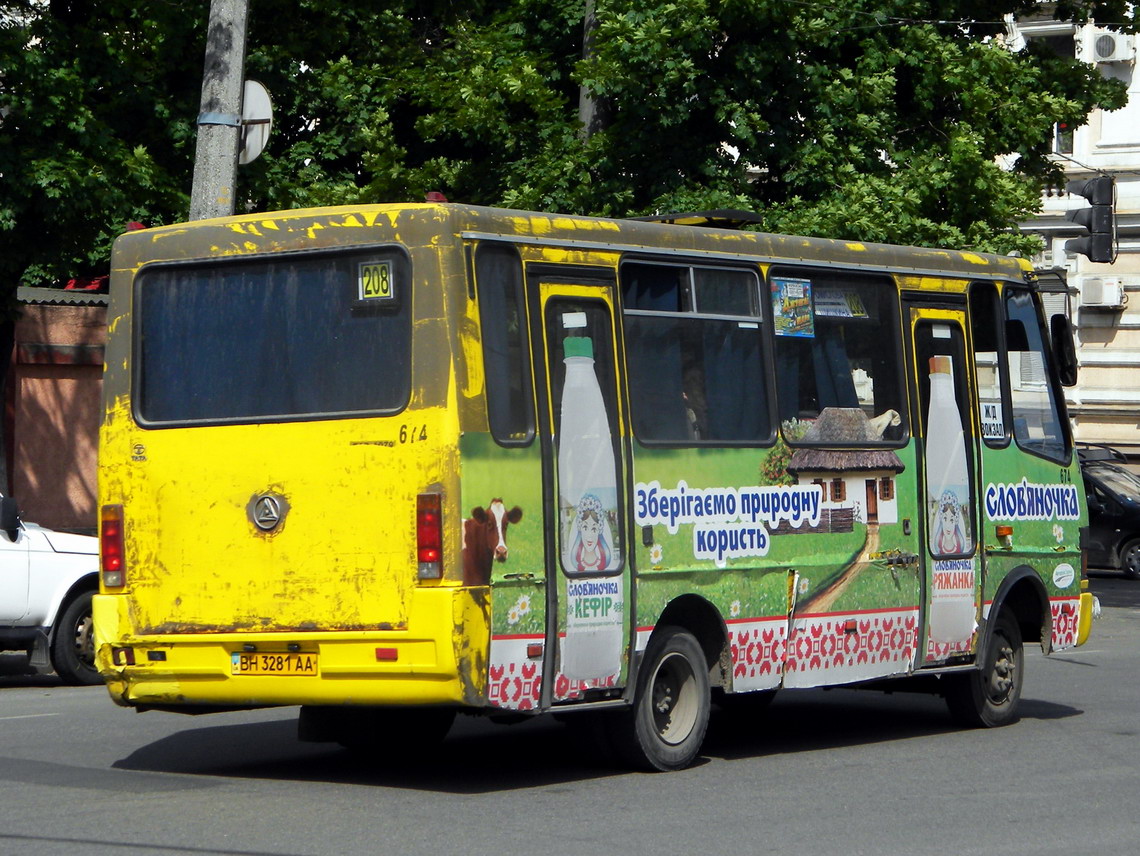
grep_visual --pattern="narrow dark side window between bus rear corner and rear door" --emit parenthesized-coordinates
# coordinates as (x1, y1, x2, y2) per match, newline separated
(475, 243, 535, 446)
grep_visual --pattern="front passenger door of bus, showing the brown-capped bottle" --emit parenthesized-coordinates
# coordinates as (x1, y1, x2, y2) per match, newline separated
(907, 301, 984, 666)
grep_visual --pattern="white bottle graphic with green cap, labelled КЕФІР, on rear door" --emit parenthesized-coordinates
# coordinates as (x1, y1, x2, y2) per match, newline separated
(557, 336, 625, 680)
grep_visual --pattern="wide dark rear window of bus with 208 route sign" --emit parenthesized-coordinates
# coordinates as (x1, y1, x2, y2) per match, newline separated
(135, 248, 412, 425)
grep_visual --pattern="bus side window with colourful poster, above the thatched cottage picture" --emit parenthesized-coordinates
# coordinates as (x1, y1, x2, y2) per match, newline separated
(768, 268, 906, 446)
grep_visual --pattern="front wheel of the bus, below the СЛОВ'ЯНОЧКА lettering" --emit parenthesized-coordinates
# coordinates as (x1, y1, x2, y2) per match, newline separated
(946, 608, 1025, 728)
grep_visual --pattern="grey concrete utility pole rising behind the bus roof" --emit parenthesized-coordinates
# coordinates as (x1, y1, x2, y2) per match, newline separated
(190, 0, 250, 220)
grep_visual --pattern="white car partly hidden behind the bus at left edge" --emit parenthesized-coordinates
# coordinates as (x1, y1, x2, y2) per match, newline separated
(0, 497, 101, 684)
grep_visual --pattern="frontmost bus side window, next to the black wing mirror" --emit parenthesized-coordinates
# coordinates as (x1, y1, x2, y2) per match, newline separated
(1005, 288, 1069, 463)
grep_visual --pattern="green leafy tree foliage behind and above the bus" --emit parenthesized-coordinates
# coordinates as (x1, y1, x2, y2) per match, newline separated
(0, 0, 1126, 287)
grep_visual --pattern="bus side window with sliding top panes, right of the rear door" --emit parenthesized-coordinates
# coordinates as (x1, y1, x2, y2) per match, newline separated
(621, 262, 772, 445)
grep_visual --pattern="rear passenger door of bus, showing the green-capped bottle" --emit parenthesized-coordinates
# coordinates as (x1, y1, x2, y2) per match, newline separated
(527, 269, 632, 706)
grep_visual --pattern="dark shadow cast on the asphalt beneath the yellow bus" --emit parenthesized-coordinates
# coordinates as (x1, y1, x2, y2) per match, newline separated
(114, 690, 1082, 794)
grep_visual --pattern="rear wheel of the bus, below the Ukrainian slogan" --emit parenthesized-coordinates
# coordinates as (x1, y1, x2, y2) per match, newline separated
(614, 627, 711, 771)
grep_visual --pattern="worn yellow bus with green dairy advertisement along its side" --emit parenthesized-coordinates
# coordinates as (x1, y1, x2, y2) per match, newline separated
(93, 203, 1092, 769)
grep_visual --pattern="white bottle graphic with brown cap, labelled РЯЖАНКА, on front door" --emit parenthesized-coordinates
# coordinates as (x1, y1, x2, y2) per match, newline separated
(926, 357, 976, 643)
